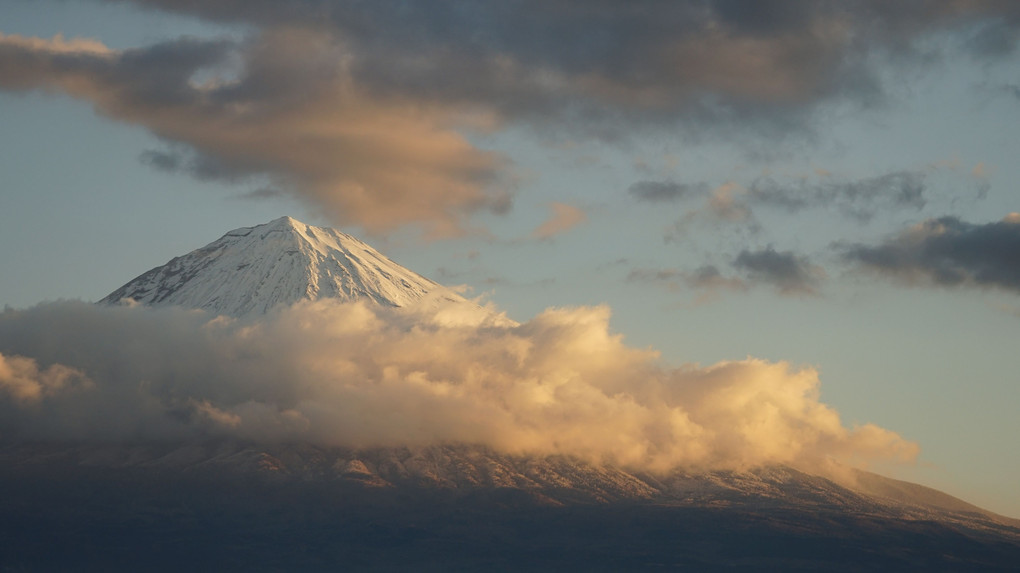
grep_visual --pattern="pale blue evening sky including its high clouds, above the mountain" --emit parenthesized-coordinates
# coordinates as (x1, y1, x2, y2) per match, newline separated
(0, 0, 1020, 517)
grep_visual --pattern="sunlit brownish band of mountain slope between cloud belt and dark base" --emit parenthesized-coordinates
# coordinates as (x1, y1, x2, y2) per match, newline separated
(7, 438, 1020, 522)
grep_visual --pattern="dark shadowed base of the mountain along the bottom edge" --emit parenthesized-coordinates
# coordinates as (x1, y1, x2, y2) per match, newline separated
(0, 468, 1020, 573)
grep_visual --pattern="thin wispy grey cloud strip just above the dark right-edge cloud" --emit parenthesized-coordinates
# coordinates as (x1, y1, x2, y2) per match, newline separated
(748, 171, 927, 221)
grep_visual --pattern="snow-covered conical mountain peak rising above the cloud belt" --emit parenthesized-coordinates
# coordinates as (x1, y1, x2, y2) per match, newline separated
(100, 217, 468, 317)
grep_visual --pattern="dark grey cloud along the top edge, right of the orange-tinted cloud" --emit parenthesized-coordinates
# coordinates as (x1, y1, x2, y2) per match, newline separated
(101, 0, 1020, 136)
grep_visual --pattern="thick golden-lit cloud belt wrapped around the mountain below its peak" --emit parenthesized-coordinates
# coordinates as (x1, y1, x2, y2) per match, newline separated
(0, 301, 917, 469)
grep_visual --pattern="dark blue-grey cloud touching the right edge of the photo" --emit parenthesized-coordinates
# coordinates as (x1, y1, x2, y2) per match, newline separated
(836, 213, 1020, 294)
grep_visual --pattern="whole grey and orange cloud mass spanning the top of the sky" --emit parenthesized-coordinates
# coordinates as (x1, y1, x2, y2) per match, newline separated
(0, 0, 1020, 230)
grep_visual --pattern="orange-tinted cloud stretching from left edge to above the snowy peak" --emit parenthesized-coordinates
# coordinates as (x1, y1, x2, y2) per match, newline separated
(0, 30, 512, 236)
